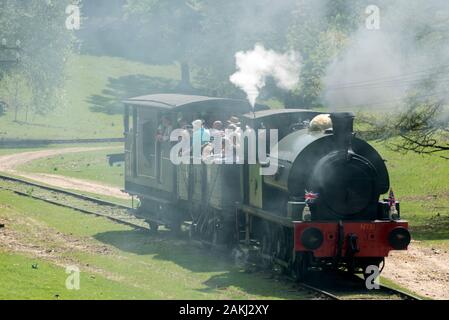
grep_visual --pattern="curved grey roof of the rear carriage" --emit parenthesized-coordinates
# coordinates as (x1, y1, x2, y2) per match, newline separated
(123, 94, 260, 114)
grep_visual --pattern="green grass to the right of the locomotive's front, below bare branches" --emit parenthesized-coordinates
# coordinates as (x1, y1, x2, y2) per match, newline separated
(373, 143, 449, 246)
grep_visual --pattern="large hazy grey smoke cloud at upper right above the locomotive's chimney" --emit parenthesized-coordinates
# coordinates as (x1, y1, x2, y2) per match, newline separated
(323, 0, 449, 110)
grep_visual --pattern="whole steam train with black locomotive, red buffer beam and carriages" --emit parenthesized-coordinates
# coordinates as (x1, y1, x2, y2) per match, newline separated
(124, 94, 411, 279)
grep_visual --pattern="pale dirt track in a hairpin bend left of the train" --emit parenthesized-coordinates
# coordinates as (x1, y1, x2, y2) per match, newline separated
(0, 147, 129, 199)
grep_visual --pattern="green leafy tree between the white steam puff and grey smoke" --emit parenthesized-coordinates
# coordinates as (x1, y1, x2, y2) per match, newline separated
(285, 0, 364, 108)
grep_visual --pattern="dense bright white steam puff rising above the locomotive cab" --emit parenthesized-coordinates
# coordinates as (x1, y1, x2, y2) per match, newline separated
(229, 44, 301, 107)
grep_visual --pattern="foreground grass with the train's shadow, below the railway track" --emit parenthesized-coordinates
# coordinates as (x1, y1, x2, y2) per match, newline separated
(0, 191, 310, 299)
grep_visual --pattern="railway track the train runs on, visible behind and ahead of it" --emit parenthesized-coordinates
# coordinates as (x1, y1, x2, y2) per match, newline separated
(0, 174, 420, 300)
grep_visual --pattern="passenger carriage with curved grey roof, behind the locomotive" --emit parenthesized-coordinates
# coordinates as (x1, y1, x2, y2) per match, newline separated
(125, 94, 260, 239)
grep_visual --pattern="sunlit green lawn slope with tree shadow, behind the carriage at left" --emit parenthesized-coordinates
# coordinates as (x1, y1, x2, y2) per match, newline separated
(0, 55, 180, 139)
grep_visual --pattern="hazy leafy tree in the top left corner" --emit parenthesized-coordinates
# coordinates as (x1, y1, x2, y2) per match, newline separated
(0, 0, 74, 119)
